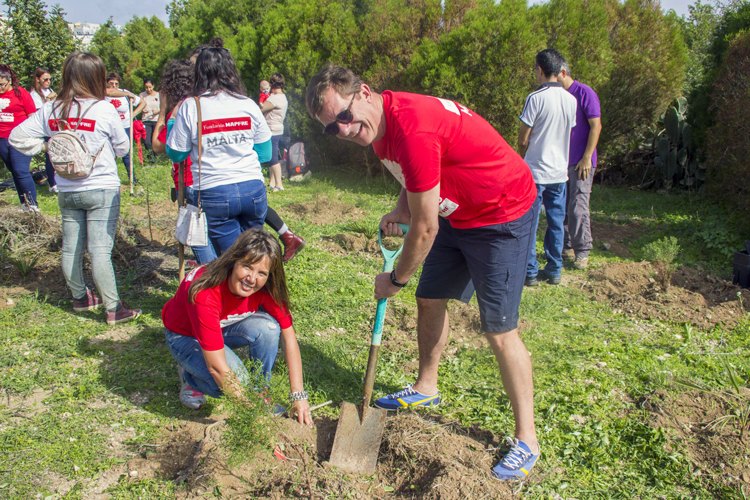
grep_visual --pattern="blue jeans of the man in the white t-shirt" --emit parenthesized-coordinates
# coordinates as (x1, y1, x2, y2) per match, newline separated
(526, 182, 566, 278)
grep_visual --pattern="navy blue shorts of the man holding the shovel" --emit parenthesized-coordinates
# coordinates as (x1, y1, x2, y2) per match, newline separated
(417, 207, 535, 333)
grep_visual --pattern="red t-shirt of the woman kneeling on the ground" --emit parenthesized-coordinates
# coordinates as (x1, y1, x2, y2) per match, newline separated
(161, 267, 292, 351)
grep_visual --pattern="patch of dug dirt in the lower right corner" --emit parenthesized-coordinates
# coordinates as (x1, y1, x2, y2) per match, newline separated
(641, 389, 750, 495)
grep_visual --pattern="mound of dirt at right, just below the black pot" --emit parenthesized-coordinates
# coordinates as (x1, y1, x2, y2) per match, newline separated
(583, 262, 750, 329)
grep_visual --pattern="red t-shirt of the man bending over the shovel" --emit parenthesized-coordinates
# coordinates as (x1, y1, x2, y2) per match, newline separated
(373, 91, 536, 229)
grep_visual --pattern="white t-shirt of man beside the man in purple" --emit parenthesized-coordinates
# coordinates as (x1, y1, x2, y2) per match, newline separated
(519, 82, 578, 184)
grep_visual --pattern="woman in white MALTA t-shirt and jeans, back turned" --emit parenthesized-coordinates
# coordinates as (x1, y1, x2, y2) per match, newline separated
(167, 47, 271, 255)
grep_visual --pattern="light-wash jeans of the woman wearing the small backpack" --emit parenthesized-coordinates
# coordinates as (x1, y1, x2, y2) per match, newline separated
(57, 189, 120, 311)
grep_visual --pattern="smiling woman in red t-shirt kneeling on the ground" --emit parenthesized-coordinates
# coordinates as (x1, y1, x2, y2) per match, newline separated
(161, 228, 313, 425)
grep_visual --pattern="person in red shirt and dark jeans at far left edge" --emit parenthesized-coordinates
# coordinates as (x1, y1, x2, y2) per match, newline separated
(0, 64, 39, 212)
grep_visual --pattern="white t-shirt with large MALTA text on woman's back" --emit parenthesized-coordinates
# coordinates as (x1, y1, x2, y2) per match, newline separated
(167, 92, 271, 190)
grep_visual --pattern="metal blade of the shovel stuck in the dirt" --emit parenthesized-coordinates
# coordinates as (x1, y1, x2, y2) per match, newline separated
(329, 401, 387, 474)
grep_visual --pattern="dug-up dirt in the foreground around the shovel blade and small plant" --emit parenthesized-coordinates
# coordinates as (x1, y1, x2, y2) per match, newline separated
(134, 413, 513, 499)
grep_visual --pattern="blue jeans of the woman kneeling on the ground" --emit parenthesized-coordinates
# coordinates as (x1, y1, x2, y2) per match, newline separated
(164, 312, 281, 398)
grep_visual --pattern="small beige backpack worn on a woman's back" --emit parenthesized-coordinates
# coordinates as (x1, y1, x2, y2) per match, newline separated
(47, 101, 104, 180)
